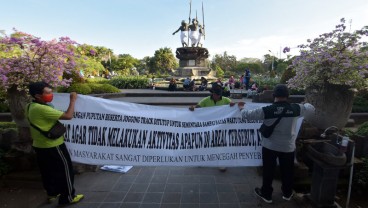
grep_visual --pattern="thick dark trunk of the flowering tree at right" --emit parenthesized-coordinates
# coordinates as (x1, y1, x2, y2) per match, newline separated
(305, 84, 354, 129)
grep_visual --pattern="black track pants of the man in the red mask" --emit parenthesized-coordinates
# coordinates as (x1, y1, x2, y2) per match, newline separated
(34, 144, 75, 204)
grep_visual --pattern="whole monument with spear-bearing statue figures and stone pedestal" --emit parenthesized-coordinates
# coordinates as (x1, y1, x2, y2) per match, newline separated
(173, 3, 216, 78)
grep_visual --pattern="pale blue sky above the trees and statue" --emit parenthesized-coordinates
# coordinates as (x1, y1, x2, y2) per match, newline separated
(0, 0, 368, 60)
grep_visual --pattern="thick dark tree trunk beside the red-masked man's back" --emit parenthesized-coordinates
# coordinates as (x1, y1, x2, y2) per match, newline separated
(7, 86, 32, 153)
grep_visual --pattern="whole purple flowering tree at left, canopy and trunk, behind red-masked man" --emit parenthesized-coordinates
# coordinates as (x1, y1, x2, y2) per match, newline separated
(0, 30, 76, 148)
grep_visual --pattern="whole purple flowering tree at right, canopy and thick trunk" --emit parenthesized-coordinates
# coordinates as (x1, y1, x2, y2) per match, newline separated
(284, 19, 368, 129)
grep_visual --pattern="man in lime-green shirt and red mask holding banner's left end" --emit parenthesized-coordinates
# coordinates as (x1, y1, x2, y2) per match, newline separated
(26, 82, 84, 205)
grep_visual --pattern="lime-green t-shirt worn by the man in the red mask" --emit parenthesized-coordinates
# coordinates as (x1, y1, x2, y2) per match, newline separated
(26, 103, 64, 148)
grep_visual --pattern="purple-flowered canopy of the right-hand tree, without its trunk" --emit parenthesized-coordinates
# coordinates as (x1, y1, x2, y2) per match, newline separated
(284, 19, 368, 89)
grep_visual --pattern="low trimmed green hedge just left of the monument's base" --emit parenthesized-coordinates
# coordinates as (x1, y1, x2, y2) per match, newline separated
(110, 76, 149, 89)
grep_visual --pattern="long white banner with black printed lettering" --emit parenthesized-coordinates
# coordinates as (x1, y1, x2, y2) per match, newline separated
(53, 93, 300, 167)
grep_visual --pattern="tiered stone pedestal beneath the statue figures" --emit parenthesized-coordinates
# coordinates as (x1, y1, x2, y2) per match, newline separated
(175, 47, 216, 78)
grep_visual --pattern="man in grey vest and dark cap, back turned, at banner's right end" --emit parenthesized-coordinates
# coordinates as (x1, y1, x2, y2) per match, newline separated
(238, 84, 314, 203)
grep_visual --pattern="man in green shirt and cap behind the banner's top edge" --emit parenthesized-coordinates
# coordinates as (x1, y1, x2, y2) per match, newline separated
(189, 82, 235, 172)
